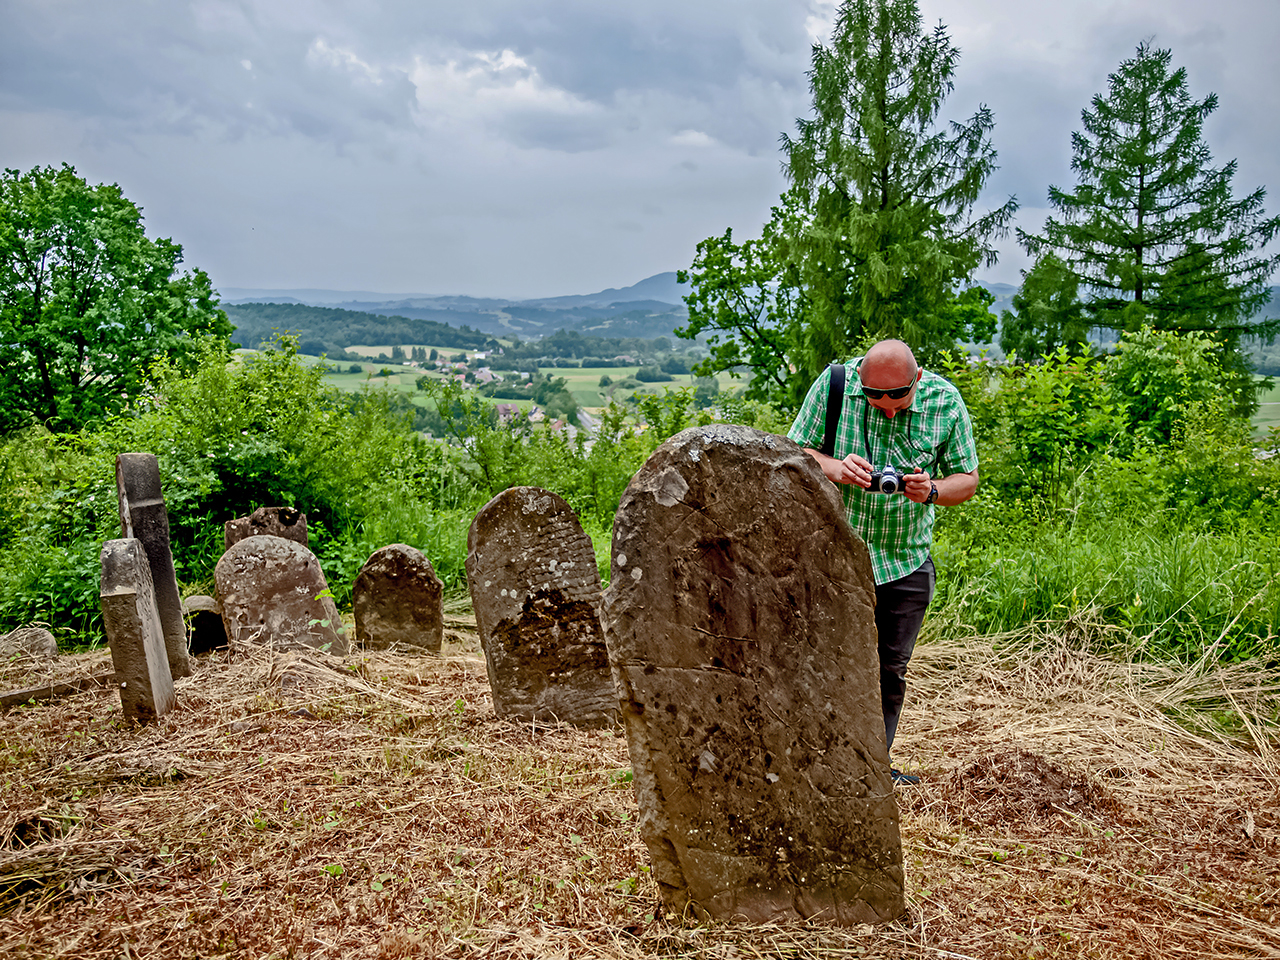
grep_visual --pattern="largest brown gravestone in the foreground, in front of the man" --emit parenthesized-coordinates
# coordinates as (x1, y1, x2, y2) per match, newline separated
(604, 425, 904, 924)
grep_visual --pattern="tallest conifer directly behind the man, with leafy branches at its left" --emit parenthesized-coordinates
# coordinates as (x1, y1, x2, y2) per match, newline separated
(682, 0, 1018, 402)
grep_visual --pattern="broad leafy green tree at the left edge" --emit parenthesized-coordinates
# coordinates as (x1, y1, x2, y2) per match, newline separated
(0, 164, 232, 431)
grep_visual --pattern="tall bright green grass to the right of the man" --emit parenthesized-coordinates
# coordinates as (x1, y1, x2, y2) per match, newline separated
(934, 522, 1280, 662)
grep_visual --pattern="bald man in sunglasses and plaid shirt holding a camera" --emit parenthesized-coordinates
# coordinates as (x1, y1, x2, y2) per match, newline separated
(787, 340, 978, 783)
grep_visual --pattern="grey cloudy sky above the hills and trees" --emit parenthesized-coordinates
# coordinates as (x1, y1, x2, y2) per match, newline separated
(0, 0, 1280, 297)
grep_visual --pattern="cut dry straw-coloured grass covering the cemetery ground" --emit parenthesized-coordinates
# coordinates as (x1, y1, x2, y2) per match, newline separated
(0, 622, 1280, 960)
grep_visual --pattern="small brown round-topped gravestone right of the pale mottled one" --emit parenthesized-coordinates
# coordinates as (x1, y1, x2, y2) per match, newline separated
(351, 543, 444, 653)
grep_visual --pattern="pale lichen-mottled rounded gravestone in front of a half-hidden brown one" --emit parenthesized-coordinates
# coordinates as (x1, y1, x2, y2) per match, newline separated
(214, 536, 347, 654)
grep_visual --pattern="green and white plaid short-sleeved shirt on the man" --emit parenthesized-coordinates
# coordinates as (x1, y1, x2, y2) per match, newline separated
(787, 357, 978, 584)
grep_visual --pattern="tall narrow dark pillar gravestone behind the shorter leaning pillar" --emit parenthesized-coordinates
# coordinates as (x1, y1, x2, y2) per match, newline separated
(115, 453, 191, 677)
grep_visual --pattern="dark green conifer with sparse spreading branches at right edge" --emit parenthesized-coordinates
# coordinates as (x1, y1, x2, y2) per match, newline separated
(1019, 44, 1280, 346)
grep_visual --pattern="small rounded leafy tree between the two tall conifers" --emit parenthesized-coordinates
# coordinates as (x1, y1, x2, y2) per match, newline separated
(1000, 252, 1089, 361)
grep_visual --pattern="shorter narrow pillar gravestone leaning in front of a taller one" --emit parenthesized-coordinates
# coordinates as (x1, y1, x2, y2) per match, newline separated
(101, 538, 177, 722)
